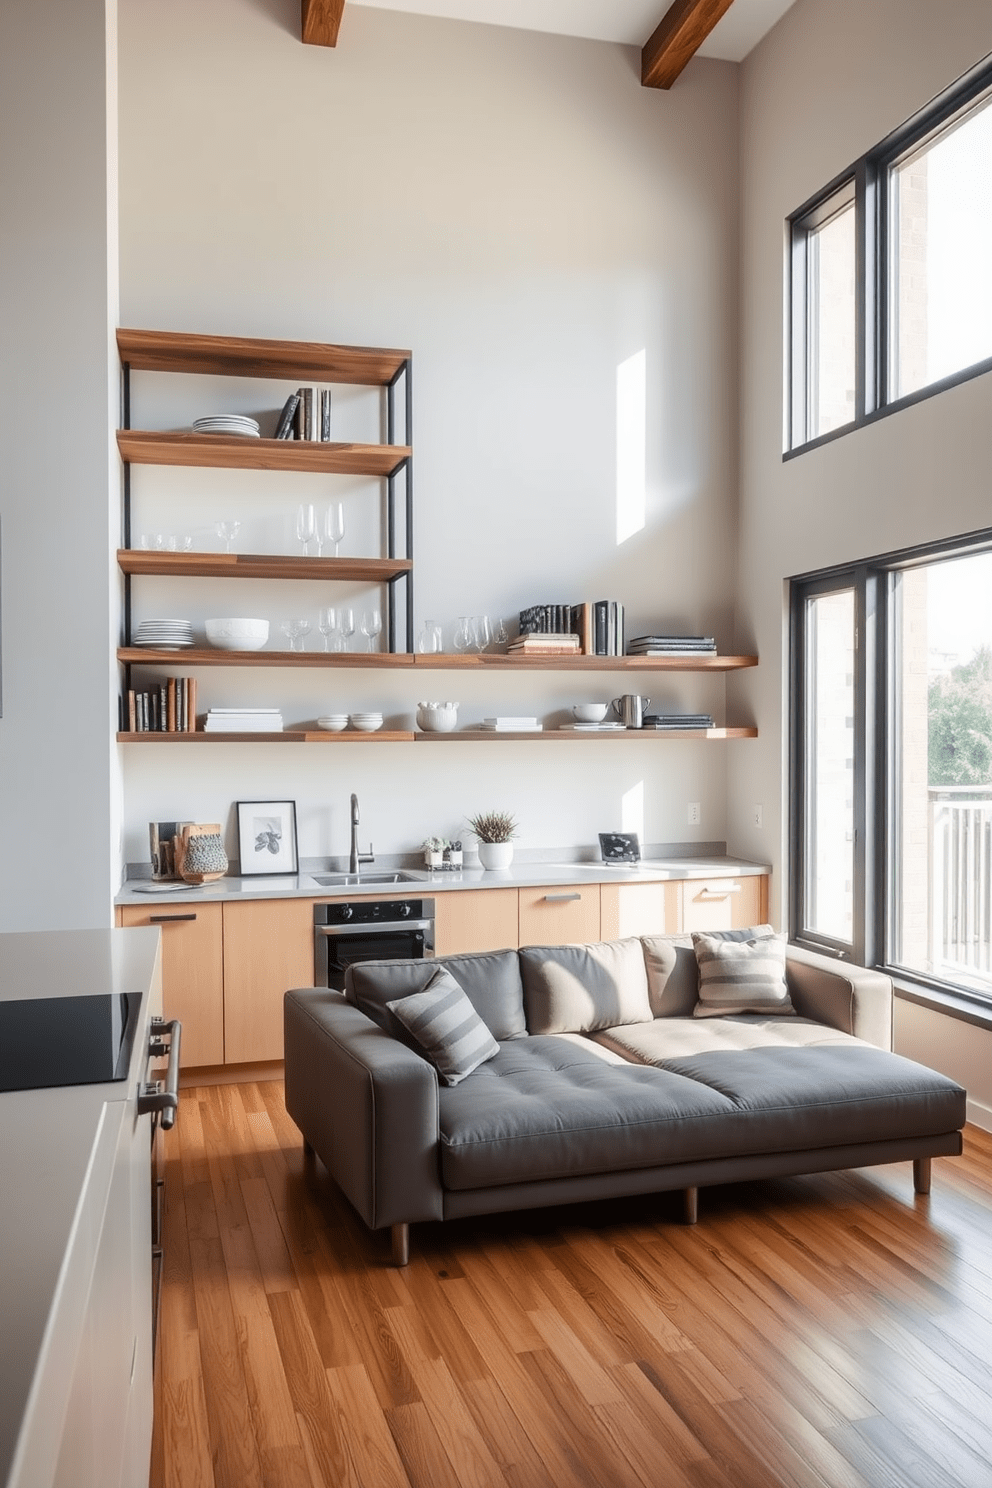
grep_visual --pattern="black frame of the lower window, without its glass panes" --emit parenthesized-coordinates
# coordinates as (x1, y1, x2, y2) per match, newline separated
(788, 527, 992, 1024)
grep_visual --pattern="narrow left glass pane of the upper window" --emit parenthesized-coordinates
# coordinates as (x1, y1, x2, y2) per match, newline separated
(806, 202, 855, 439)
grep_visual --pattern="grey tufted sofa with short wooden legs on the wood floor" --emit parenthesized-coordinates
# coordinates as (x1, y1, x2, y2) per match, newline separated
(286, 931, 965, 1265)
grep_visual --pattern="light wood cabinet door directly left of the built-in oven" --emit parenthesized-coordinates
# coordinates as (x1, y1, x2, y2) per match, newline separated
(225, 899, 314, 1064)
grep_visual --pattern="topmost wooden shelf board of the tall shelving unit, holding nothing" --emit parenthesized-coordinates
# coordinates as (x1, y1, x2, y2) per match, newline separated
(117, 327, 410, 387)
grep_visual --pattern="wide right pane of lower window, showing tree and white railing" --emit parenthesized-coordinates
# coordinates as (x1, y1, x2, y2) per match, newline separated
(889, 554, 992, 994)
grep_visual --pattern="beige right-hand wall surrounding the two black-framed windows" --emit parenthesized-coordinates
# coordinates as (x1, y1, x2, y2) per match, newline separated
(729, 0, 992, 1106)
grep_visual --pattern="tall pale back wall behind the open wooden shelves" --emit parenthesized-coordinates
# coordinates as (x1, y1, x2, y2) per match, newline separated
(120, 0, 740, 860)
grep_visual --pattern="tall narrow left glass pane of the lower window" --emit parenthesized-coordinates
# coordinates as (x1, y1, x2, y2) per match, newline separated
(805, 589, 854, 943)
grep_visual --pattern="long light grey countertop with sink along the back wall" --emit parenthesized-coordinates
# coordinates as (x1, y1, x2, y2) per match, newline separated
(115, 857, 770, 905)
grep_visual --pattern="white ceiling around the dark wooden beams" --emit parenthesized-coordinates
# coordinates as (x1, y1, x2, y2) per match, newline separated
(350, 0, 794, 62)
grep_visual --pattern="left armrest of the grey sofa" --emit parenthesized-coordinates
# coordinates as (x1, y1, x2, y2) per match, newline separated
(284, 988, 442, 1229)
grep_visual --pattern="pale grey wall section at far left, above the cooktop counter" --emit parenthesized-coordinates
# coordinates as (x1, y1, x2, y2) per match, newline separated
(0, 0, 119, 930)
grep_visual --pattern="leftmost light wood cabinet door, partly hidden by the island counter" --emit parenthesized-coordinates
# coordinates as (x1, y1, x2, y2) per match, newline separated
(119, 903, 225, 1070)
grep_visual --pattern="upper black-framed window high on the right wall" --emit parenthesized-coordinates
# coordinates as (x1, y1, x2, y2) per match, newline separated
(785, 60, 992, 454)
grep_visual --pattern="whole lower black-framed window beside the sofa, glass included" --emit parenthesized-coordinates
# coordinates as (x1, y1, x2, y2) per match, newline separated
(791, 533, 992, 1003)
